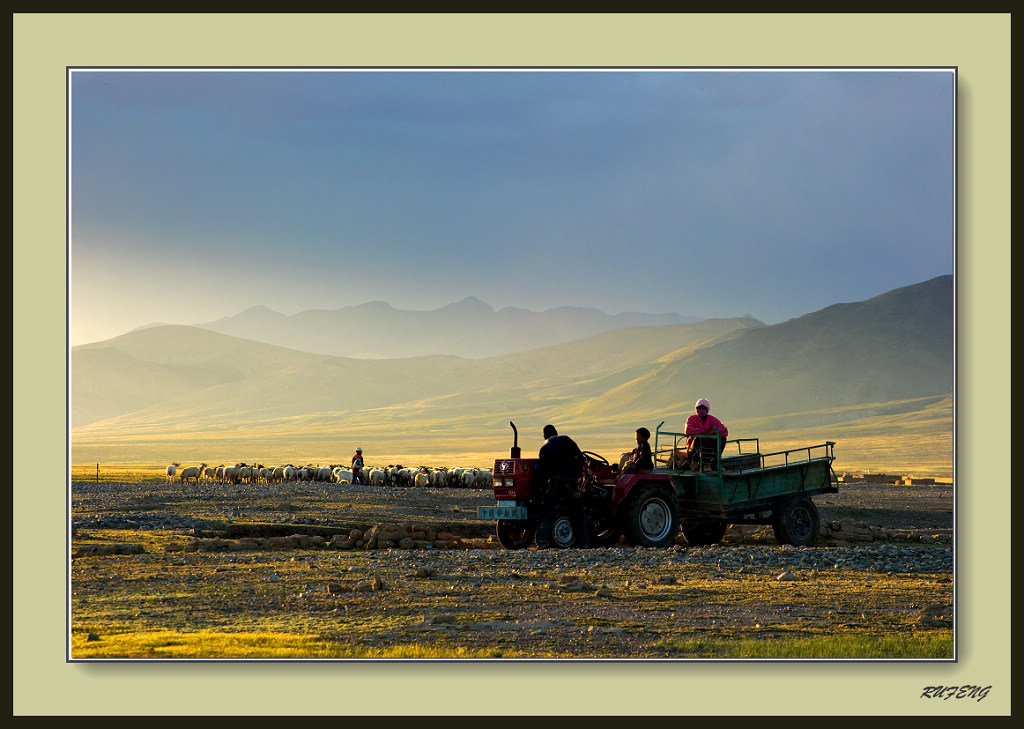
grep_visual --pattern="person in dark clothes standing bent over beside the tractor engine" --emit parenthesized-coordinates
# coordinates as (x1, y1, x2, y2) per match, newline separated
(531, 425, 590, 547)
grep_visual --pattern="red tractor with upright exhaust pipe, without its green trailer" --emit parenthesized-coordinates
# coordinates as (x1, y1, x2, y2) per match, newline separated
(477, 423, 679, 549)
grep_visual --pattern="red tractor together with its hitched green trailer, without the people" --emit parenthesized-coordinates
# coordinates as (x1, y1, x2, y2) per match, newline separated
(477, 422, 839, 549)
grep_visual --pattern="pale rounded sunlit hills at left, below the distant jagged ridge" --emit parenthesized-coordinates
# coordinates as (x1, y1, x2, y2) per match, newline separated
(72, 319, 763, 428)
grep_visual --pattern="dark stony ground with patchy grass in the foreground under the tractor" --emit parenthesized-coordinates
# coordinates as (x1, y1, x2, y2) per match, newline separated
(71, 482, 954, 657)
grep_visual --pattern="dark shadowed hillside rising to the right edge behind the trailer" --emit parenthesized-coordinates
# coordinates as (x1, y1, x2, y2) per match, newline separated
(574, 276, 954, 418)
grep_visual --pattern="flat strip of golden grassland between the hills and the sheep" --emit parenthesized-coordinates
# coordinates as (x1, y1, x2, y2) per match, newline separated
(71, 408, 953, 482)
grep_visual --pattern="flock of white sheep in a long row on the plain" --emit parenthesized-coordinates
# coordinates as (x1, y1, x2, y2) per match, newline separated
(167, 463, 492, 488)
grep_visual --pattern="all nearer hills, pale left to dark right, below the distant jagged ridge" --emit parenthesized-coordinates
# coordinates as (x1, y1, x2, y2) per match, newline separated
(72, 276, 953, 444)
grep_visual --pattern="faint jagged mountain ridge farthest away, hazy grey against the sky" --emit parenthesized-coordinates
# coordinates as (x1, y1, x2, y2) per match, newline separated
(196, 297, 700, 359)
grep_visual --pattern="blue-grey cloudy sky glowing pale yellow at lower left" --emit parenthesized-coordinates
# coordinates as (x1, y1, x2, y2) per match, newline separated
(68, 69, 956, 345)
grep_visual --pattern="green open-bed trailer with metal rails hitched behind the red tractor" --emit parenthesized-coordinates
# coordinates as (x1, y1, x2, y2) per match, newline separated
(654, 423, 839, 546)
